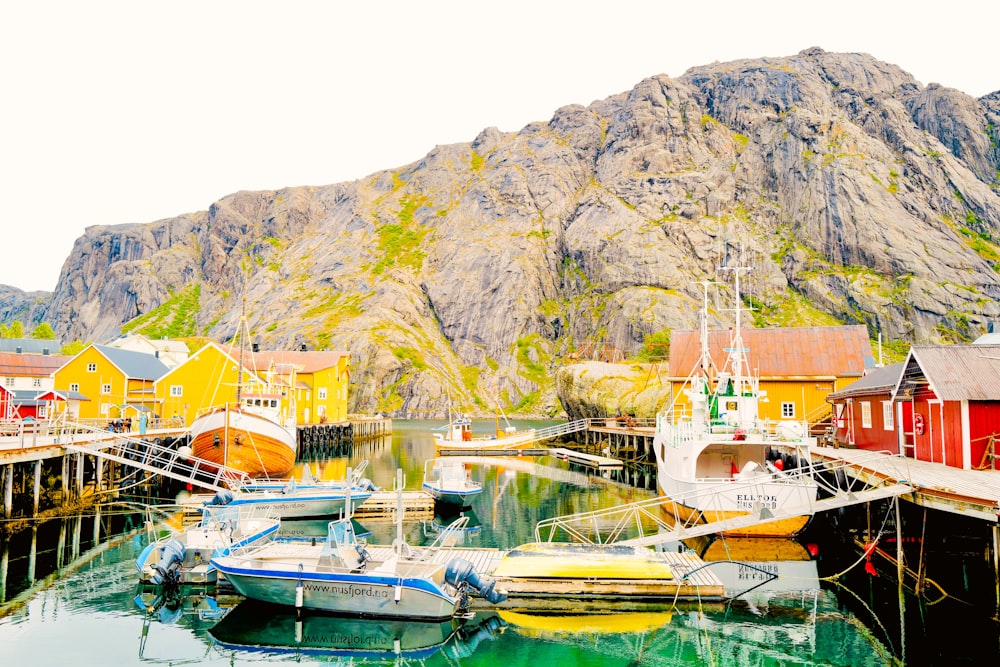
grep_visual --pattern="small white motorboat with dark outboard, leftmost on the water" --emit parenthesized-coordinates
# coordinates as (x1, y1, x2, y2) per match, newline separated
(135, 507, 280, 585)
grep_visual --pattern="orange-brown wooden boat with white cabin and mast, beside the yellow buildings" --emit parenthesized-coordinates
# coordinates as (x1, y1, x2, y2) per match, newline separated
(191, 305, 298, 477)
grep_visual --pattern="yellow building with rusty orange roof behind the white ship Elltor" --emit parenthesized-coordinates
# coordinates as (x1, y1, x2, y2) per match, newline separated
(668, 325, 875, 424)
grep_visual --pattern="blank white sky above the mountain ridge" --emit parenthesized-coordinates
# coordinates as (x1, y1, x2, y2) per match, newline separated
(0, 0, 1000, 290)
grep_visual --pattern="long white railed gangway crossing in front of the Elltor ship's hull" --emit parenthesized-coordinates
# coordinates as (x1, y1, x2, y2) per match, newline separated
(535, 456, 913, 546)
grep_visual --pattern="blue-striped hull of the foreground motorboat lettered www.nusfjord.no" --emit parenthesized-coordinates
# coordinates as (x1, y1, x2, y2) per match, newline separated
(213, 557, 458, 621)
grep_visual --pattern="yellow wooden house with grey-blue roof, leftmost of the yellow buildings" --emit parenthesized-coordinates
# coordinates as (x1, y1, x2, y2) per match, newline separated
(53, 345, 167, 419)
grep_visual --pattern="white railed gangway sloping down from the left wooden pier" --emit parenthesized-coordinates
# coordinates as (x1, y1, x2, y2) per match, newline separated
(62, 424, 250, 491)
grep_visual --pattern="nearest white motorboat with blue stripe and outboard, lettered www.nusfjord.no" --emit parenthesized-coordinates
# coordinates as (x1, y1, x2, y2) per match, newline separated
(213, 471, 504, 621)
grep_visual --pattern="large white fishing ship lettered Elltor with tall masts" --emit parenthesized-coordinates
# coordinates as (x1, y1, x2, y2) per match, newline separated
(653, 268, 817, 537)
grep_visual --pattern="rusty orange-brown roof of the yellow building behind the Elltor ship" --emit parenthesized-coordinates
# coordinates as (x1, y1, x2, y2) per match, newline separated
(669, 325, 873, 377)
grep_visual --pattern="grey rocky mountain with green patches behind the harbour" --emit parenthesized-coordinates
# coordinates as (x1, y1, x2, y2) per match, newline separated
(0, 48, 1000, 417)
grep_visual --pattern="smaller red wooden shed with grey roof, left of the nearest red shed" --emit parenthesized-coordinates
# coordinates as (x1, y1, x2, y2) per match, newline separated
(827, 363, 912, 454)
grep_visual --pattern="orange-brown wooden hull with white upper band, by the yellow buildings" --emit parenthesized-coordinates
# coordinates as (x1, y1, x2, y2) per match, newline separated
(191, 407, 297, 477)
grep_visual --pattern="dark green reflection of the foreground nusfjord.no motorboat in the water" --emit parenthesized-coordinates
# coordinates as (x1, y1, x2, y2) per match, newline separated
(209, 600, 504, 660)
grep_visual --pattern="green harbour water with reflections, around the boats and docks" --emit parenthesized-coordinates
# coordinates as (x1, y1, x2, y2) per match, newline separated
(0, 421, 1000, 667)
